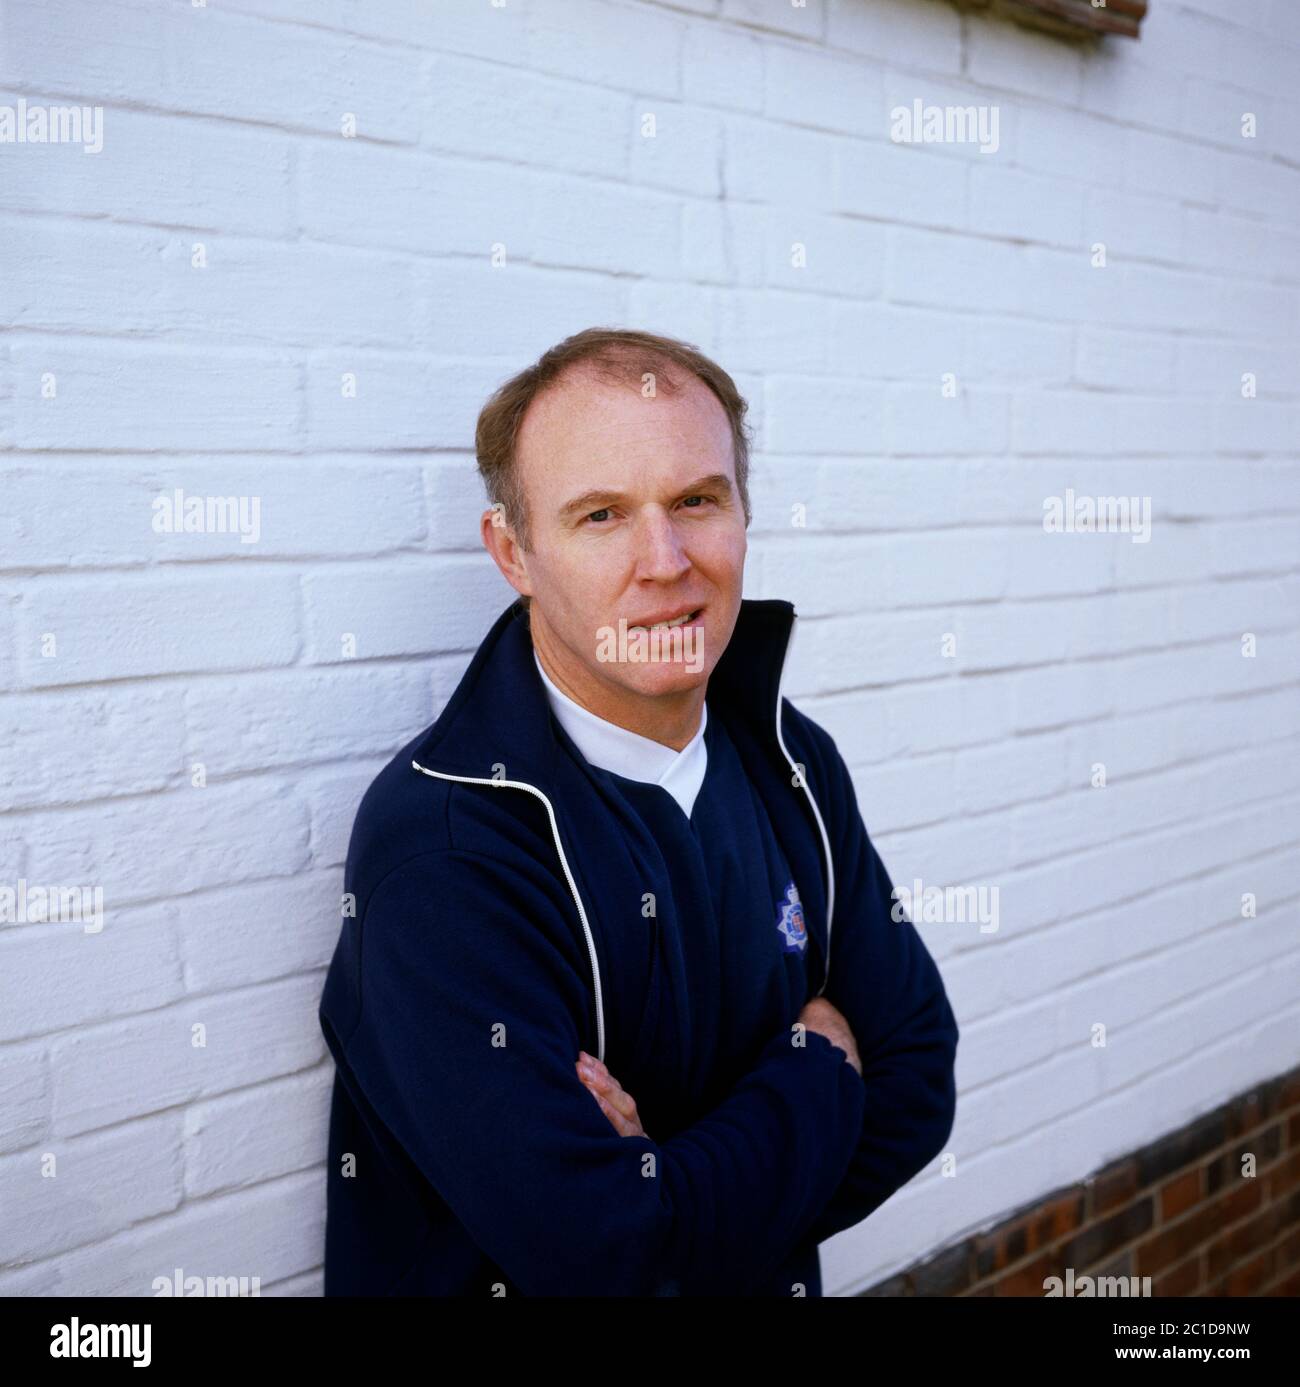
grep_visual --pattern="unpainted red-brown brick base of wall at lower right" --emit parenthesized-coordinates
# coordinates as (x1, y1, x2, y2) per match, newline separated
(863, 1068, 1300, 1295)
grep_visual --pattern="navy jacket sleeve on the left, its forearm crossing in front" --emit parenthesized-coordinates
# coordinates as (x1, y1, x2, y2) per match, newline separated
(331, 849, 864, 1295)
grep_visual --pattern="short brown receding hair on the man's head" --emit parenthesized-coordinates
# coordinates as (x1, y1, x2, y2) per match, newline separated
(474, 327, 751, 551)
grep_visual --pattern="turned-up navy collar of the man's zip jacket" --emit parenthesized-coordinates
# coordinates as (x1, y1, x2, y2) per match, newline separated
(415, 598, 795, 788)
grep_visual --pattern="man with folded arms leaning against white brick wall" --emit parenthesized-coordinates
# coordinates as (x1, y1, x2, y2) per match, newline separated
(320, 329, 957, 1295)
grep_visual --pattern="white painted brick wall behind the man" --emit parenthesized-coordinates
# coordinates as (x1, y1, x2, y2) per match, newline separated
(0, 0, 1300, 1295)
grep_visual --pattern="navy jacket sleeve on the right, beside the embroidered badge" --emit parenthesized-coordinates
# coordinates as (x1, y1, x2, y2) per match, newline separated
(796, 714, 959, 1241)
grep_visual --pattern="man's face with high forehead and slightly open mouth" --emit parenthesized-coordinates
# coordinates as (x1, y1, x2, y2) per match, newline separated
(488, 363, 746, 725)
